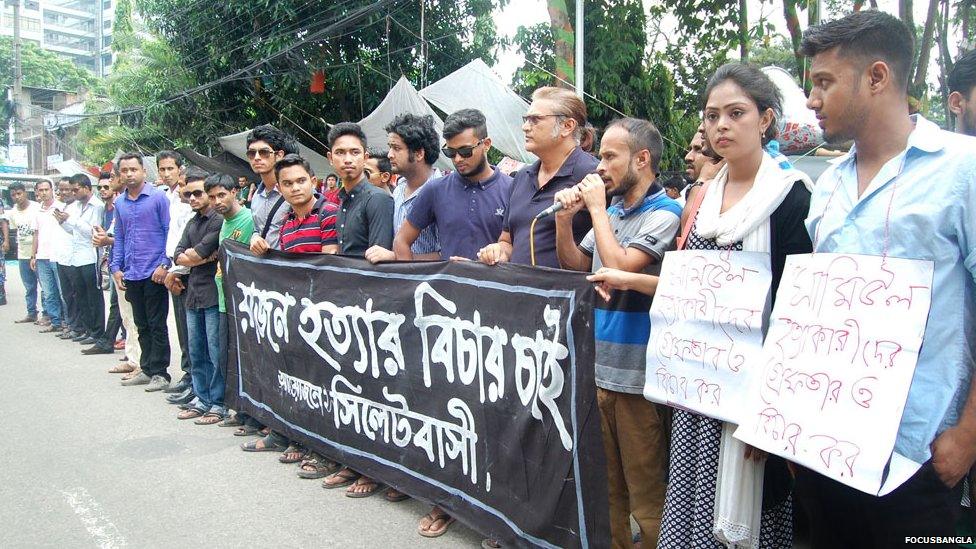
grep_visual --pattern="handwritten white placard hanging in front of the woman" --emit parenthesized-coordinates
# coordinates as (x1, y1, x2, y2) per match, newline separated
(644, 250, 771, 423)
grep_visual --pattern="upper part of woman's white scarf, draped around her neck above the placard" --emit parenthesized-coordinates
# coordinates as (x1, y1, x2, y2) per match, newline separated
(695, 153, 813, 249)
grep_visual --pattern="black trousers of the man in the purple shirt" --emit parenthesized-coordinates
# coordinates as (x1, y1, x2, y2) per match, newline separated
(125, 278, 169, 381)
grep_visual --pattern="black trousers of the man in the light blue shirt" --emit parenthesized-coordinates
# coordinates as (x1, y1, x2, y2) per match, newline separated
(795, 461, 962, 549)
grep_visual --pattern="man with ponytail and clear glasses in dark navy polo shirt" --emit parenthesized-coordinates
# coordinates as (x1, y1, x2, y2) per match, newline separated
(478, 87, 597, 269)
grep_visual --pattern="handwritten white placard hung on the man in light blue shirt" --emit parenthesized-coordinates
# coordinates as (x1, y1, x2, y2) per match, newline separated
(735, 254, 932, 494)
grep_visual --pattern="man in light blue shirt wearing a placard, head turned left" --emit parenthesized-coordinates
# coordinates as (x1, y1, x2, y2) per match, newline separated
(796, 11, 976, 548)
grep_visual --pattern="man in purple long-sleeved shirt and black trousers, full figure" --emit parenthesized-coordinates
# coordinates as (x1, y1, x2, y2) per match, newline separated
(111, 153, 170, 391)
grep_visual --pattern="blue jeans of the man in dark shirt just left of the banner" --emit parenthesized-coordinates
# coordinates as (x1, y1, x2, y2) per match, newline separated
(186, 305, 226, 415)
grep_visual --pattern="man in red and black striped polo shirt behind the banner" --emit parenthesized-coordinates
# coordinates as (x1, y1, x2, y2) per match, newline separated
(275, 154, 339, 254)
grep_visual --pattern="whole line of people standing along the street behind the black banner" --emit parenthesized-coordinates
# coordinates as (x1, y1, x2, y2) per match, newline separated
(3, 11, 976, 548)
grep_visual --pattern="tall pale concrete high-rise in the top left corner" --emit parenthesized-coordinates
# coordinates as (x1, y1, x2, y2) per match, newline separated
(0, 0, 115, 76)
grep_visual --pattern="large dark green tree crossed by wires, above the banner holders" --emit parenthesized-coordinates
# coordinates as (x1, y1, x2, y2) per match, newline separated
(78, 0, 505, 160)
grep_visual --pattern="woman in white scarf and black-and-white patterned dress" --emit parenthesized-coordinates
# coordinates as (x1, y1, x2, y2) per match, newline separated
(591, 63, 812, 549)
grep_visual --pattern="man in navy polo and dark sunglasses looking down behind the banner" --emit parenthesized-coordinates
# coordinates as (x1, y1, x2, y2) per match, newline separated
(393, 109, 512, 261)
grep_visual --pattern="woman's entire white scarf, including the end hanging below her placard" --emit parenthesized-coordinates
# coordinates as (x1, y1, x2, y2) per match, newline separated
(708, 153, 813, 547)
